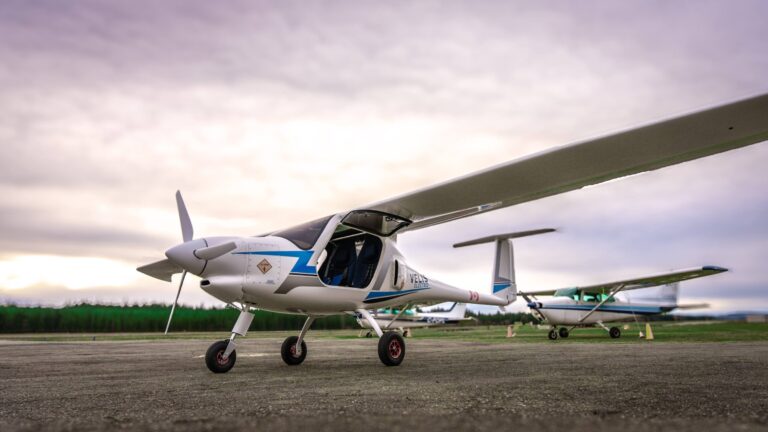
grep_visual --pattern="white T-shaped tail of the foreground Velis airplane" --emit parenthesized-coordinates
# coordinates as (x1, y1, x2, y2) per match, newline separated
(453, 228, 555, 304)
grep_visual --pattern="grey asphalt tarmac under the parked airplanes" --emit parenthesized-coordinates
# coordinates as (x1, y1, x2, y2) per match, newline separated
(0, 334, 768, 432)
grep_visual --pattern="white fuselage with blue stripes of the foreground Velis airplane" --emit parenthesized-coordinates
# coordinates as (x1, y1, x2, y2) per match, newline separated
(167, 215, 506, 315)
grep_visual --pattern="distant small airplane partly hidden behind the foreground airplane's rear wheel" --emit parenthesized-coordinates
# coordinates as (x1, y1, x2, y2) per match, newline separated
(356, 302, 471, 337)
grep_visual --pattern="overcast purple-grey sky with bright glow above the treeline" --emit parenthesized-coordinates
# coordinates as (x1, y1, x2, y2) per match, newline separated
(0, 0, 768, 311)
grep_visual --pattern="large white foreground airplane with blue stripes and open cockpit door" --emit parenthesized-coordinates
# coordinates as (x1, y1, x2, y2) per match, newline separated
(138, 94, 768, 373)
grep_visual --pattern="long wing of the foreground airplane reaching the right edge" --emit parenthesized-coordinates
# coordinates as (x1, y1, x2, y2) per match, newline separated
(360, 94, 768, 232)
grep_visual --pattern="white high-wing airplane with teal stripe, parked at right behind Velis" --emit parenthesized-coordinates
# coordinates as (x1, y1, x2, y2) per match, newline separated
(519, 266, 728, 340)
